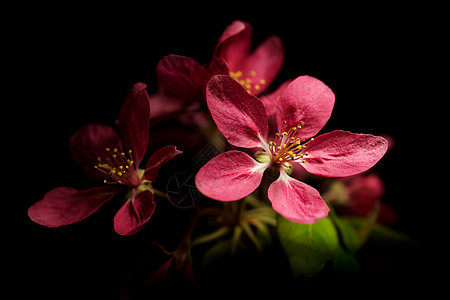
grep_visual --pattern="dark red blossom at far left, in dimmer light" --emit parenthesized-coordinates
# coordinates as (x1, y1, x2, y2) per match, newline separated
(28, 83, 182, 235)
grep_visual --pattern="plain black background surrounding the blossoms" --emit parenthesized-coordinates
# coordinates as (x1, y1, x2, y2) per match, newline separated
(15, 3, 445, 299)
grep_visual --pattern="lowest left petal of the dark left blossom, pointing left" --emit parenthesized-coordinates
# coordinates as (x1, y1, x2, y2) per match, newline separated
(28, 186, 121, 227)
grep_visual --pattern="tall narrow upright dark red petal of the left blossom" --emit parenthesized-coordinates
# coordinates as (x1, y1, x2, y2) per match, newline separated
(119, 82, 150, 166)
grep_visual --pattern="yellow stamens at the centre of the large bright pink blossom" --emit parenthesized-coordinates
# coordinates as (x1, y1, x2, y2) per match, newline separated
(269, 121, 314, 169)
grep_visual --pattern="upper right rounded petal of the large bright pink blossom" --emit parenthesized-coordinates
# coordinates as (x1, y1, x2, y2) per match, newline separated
(277, 76, 334, 141)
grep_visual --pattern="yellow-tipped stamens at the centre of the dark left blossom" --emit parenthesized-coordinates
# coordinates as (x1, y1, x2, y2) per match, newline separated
(94, 148, 140, 187)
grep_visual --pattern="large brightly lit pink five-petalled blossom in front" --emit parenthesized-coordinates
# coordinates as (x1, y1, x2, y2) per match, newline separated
(195, 75, 388, 224)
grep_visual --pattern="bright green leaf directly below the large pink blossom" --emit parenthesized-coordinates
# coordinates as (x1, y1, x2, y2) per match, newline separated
(278, 216, 339, 278)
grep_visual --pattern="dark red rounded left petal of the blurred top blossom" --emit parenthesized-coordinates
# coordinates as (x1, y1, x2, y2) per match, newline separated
(156, 54, 208, 102)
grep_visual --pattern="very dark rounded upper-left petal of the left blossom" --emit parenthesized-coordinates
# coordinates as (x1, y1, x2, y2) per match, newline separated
(69, 124, 122, 168)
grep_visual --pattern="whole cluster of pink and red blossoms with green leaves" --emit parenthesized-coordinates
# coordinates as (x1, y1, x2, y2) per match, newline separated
(28, 21, 408, 285)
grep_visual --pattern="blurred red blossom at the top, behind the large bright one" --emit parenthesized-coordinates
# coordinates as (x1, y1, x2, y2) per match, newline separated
(151, 20, 284, 117)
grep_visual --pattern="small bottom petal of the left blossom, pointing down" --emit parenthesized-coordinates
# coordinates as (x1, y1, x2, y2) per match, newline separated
(114, 190, 156, 235)
